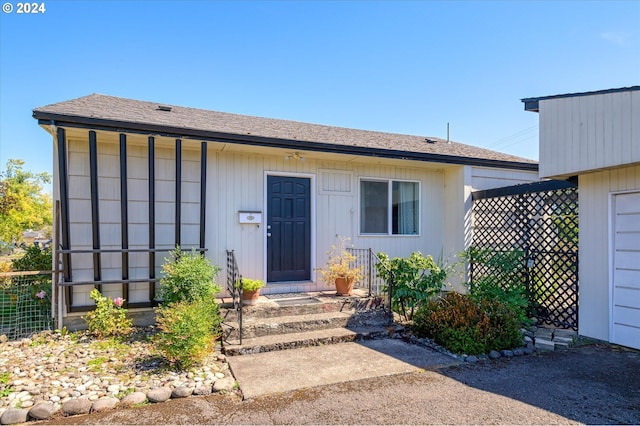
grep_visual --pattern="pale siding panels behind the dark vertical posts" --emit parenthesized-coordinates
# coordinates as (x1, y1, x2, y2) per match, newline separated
(62, 132, 200, 306)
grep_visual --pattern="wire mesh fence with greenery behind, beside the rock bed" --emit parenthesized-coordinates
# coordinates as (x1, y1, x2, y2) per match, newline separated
(0, 271, 53, 340)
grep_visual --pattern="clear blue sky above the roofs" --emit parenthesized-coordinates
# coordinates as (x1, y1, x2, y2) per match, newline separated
(0, 0, 640, 179)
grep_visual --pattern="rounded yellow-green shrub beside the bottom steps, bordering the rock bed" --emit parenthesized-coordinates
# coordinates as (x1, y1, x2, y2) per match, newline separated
(155, 299, 221, 368)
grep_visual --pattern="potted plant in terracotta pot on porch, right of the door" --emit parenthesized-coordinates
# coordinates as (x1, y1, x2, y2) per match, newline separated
(318, 237, 362, 296)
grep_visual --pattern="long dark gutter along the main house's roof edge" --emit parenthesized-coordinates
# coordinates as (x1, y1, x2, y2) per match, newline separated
(33, 110, 538, 171)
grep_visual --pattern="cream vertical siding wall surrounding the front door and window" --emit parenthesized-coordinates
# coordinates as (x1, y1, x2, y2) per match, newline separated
(206, 149, 445, 292)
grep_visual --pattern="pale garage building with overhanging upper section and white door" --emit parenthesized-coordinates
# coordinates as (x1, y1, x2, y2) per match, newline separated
(522, 86, 640, 349)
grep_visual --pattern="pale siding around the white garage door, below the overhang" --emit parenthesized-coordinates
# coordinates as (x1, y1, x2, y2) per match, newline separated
(578, 165, 640, 341)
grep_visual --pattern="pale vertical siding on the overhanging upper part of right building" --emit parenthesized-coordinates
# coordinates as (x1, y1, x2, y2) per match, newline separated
(540, 90, 640, 178)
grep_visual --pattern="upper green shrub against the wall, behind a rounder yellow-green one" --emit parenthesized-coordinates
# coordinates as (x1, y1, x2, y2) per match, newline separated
(160, 247, 220, 304)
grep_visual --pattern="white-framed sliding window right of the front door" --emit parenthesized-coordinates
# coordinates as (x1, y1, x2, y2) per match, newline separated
(360, 179, 420, 235)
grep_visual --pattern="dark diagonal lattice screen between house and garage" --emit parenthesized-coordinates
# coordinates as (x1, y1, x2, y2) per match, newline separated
(471, 181, 578, 330)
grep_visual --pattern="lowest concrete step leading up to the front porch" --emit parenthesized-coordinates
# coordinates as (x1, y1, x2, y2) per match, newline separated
(223, 327, 393, 356)
